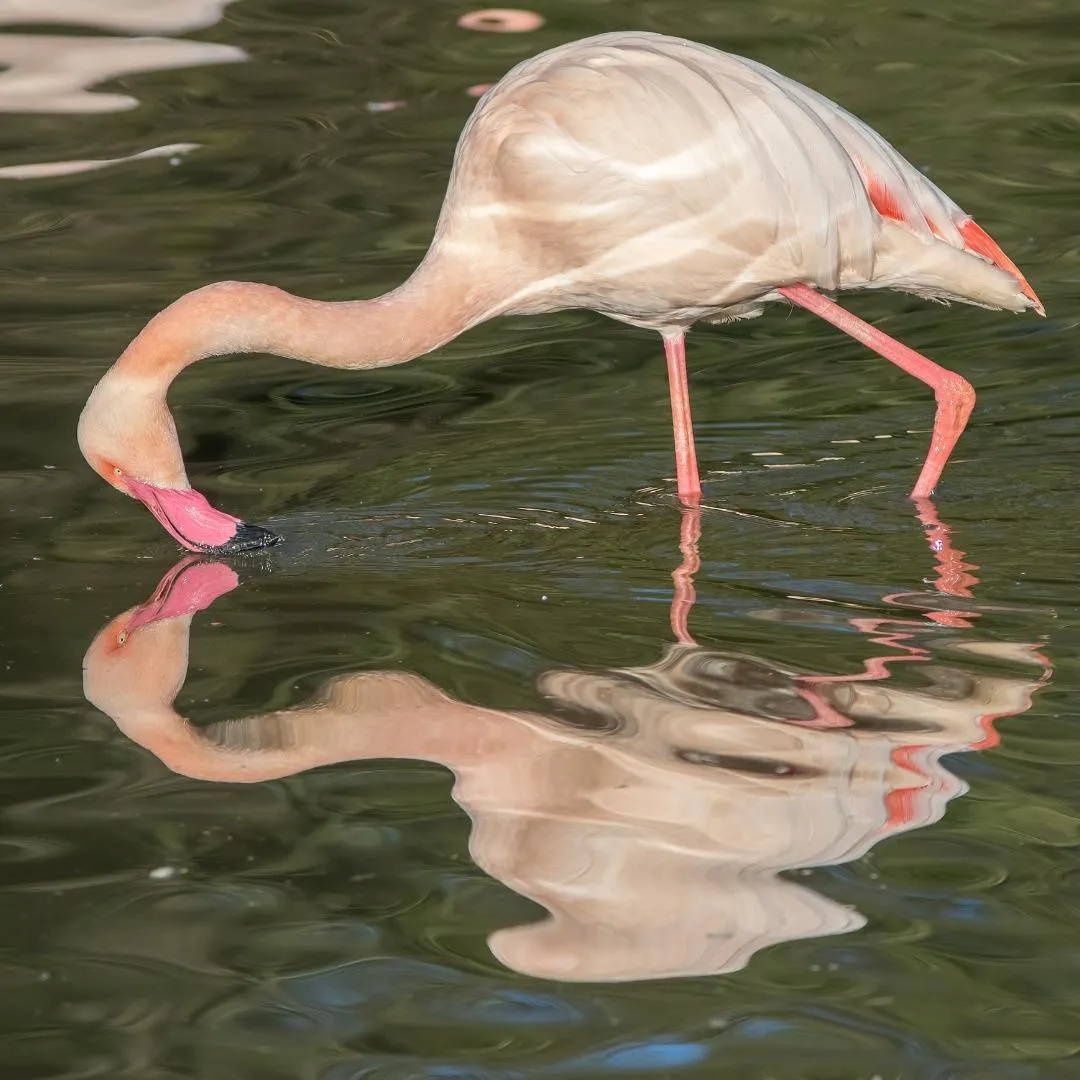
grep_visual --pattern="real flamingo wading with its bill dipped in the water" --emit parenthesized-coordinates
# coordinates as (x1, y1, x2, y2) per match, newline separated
(79, 31, 1043, 554)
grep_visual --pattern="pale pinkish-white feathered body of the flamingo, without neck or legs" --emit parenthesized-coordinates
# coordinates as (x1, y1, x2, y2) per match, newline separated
(437, 32, 1034, 328)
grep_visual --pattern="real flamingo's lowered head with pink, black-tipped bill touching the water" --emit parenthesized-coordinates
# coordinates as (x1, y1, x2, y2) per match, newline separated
(79, 368, 281, 555)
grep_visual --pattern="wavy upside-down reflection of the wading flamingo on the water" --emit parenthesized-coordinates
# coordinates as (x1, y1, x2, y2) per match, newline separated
(85, 501, 1045, 980)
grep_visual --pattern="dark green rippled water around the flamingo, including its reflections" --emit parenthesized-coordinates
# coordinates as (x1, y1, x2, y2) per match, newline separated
(0, 0, 1080, 1080)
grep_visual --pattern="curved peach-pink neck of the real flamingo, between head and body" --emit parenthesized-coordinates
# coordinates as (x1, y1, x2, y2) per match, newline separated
(114, 258, 491, 386)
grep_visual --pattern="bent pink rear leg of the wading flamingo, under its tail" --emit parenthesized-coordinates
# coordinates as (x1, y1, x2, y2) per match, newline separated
(781, 285, 975, 499)
